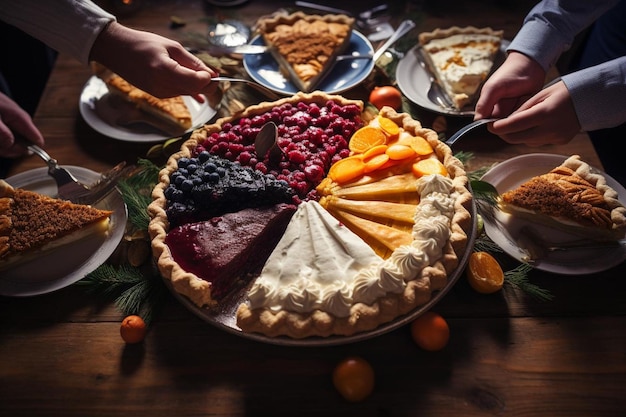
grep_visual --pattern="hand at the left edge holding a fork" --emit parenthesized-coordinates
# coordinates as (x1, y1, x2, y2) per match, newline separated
(0, 93, 44, 158)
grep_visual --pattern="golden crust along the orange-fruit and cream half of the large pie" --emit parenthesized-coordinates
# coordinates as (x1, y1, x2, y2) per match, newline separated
(237, 107, 472, 339)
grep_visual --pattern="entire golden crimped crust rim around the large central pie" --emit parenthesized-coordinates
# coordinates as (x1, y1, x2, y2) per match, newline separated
(148, 96, 472, 339)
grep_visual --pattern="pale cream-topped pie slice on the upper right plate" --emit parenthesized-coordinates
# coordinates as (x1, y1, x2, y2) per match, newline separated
(419, 26, 503, 110)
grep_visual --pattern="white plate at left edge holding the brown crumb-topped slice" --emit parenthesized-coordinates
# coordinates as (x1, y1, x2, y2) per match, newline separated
(0, 166, 127, 296)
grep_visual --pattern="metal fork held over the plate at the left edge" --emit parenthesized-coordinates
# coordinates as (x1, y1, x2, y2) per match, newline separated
(18, 138, 128, 205)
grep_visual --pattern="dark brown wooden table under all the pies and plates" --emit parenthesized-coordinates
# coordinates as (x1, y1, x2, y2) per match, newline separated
(0, 0, 626, 417)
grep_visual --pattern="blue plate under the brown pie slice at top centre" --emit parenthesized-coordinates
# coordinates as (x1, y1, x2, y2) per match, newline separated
(243, 31, 374, 95)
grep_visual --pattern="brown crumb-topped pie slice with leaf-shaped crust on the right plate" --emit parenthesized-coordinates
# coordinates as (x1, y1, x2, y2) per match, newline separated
(500, 155, 626, 240)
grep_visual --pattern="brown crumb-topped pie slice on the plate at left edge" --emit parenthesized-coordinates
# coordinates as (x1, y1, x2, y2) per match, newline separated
(0, 180, 112, 270)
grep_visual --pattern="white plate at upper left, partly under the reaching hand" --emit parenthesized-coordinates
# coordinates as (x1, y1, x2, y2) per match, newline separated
(78, 75, 217, 143)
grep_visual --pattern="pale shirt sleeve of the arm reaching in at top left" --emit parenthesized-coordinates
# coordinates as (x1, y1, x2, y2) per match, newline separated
(0, 0, 116, 64)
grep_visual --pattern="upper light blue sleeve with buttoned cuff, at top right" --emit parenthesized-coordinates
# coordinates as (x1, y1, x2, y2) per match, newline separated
(507, 0, 619, 71)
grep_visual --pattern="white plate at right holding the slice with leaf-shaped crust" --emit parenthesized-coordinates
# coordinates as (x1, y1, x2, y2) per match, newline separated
(482, 153, 626, 275)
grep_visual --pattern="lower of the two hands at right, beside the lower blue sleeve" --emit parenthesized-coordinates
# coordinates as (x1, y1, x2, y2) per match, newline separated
(488, 81, 580, 146)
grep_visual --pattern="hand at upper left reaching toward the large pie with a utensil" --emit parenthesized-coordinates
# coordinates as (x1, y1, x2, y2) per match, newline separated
(90, 22, 218, 102)
